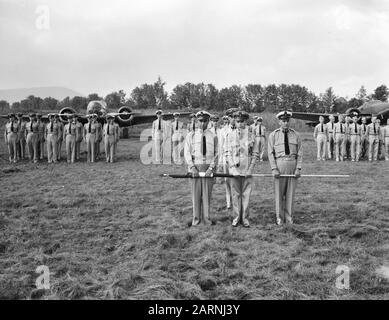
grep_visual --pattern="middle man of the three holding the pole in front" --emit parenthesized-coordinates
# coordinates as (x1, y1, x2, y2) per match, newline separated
(226, 111, 259, 228)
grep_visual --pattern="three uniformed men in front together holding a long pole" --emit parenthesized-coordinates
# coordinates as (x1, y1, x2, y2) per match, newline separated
(180, 109, 302, 227)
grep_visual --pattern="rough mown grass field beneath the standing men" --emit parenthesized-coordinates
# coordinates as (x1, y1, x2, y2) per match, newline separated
(0, 119, 389, 299)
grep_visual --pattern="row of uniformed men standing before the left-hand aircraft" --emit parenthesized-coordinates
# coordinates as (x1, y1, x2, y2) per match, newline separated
(4, 113, 119, 163)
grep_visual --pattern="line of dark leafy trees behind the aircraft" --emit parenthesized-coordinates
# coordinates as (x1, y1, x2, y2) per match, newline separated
(0, 77, 389, 113)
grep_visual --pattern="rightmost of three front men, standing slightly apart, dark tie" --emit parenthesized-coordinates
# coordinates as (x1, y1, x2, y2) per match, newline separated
(267, 111, 303, 225)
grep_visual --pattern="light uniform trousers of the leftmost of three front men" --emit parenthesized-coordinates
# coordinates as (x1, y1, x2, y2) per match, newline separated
(191, 172, 214, 226)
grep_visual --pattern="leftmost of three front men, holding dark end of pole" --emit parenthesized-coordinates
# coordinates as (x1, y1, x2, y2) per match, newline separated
(184, 111, 218, 226)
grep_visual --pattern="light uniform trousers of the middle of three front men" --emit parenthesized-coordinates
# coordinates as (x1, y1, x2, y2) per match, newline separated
(230, 177, 253, 224)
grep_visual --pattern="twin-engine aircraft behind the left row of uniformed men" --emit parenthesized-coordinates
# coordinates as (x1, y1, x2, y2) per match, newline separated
(0, 100, 191, 127)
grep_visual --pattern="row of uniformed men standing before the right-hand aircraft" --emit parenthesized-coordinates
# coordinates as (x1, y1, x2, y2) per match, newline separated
(313, 113, 389, 161)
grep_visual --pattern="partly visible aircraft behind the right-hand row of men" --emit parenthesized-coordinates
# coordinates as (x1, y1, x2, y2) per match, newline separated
(292, 100, 389, 126)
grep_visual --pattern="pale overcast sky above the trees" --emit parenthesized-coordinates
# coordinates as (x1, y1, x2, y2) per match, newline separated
(0, 0, 389, 97)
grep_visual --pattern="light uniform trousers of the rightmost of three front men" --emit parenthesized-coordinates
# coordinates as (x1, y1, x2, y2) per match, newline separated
(274, 158, 297, 222)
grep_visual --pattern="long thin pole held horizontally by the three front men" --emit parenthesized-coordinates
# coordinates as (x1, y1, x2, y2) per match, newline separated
(161, 172, 350, 179)
